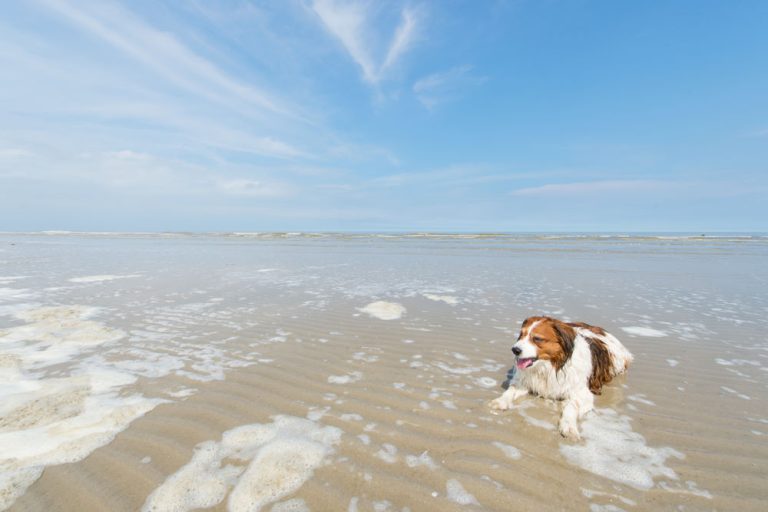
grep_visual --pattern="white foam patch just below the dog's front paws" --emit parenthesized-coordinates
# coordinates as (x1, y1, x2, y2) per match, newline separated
(560, 409, 684, 490)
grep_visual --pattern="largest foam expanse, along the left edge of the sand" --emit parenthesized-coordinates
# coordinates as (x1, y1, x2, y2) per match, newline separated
(0, 306, 162, 510)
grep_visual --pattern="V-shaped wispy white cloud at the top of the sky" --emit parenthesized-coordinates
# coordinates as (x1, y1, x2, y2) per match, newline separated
(312, 0, 421, 85)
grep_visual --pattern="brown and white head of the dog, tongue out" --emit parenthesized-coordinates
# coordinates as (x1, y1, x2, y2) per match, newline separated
(512, 316, 576, 370)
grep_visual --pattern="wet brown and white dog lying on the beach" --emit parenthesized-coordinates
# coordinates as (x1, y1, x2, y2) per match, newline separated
(491, 316, 633, 439)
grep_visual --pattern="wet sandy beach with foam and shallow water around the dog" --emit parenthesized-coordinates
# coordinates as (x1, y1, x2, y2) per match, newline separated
(0, 232, 768, 512)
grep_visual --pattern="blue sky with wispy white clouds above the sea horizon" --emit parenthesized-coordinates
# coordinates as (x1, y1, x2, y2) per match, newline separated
(0, 0, 768, 232)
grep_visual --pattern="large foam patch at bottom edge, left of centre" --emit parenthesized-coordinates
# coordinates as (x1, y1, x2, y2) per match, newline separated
(142, 416, 342, 512)
